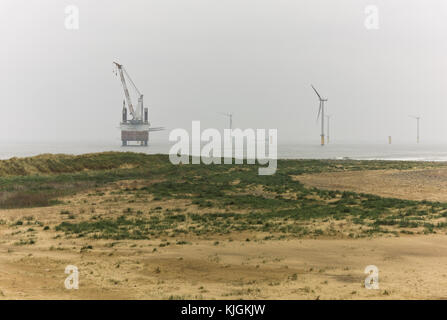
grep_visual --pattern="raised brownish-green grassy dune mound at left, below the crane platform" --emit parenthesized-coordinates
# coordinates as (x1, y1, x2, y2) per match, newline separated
(0, 152, 166, 208)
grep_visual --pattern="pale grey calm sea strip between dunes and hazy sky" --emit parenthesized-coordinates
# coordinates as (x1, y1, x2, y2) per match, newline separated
(0, 141, 447, 161)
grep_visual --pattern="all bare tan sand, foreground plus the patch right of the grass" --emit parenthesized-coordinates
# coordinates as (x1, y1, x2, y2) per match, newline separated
(0, 169, 447, 299)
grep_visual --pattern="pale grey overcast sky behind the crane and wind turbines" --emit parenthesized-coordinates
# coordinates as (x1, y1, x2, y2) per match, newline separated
(0, 0, 447, 143)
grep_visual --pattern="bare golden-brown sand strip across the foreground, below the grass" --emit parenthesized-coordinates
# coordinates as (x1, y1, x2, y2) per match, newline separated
(0, 229, 447, 299)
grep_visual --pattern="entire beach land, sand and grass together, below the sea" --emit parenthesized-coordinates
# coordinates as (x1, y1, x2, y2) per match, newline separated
(0, 153, 447, 299)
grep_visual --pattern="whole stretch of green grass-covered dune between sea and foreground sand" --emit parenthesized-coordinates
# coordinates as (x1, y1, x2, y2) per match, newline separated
(0, 152, 447, 239)
